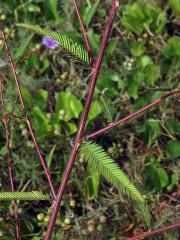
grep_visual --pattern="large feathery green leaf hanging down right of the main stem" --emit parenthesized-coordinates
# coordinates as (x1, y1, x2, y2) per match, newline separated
(81, 141, 150, 226)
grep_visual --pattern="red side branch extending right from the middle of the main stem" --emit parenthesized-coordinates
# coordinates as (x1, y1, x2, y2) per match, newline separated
(82, 89, 180, 141)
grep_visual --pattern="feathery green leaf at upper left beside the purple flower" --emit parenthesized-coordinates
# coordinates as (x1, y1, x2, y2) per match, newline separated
(16, 23, 90, 64)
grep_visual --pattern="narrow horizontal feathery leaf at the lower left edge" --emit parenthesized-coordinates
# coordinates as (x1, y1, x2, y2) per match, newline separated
(0, 191, 50, 201)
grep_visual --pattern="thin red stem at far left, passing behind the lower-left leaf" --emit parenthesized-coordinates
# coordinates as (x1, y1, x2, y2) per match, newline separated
(0, 72, 21, 240)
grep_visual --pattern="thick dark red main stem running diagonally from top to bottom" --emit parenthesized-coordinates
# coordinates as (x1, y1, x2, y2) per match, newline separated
(45, 0, 119, 240)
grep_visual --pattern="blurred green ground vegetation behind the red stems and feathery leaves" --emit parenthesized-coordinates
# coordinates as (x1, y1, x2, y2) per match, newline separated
(0, 0, 180, 240)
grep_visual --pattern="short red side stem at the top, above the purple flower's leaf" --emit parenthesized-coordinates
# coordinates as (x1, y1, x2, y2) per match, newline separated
(73, 0, 94, 67)
